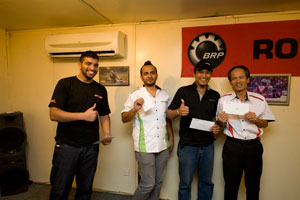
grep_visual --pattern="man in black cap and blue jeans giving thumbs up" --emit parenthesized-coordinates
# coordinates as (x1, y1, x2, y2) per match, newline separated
(167, 61, 220, 200)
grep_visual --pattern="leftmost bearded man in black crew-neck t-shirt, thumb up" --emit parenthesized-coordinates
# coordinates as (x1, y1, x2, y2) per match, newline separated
(49, 51, 111, 200)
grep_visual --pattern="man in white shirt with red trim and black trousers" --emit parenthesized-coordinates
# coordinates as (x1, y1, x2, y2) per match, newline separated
(217, 65, 275, 200)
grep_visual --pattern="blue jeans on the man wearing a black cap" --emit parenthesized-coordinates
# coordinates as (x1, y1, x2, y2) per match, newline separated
(177, 144, 214, 200)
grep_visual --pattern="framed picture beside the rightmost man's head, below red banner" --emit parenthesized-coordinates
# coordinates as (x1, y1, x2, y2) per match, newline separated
(248, 74, 291, 105)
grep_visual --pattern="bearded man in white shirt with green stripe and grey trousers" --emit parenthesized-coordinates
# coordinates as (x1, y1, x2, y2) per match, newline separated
(121, 61, 174, 200)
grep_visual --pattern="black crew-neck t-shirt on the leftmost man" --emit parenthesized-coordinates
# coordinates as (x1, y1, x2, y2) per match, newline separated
(49, 76, 110, 146)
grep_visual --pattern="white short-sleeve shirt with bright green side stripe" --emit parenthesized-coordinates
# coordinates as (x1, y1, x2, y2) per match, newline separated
(122, 88, 171, 153)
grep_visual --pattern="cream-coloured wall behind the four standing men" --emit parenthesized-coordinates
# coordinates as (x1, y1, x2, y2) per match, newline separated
(5, 12, 300, 200)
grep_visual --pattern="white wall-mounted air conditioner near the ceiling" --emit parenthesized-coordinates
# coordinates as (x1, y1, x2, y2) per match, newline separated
(45, 31, 125, 58)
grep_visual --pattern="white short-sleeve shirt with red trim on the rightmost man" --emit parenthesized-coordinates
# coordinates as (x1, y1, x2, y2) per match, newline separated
(217, 91, 275, 140)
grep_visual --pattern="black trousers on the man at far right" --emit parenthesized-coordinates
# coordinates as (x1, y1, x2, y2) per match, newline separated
(222, 138, 263, 200)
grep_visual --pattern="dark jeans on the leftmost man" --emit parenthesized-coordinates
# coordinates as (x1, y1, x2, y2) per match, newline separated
(49, 144, 99, 200)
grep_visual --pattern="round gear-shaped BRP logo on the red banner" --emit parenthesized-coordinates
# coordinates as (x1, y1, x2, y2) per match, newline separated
(188, 33, 226, 68)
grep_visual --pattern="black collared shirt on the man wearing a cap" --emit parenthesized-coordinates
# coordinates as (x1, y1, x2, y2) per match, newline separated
(169, 83, 220, 146)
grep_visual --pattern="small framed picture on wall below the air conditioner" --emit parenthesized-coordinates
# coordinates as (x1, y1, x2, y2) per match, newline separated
(99, 66, 129, 86)
